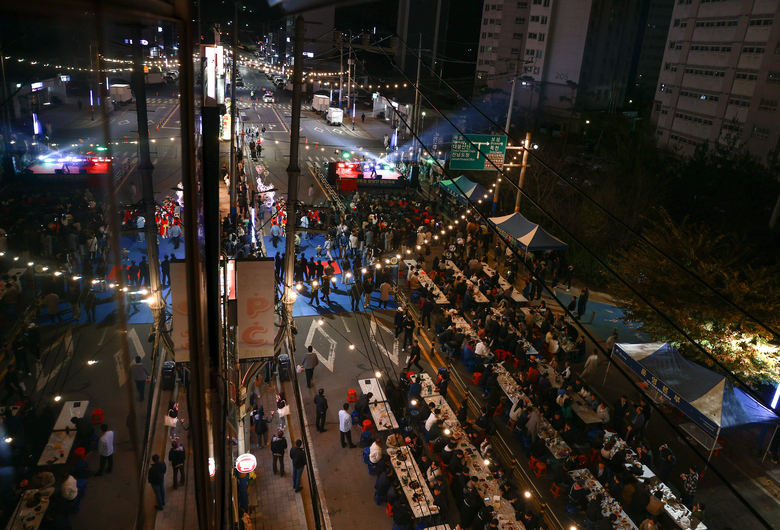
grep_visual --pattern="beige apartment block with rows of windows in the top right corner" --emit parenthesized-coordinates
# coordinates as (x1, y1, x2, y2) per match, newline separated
(653, 0, 780, 157)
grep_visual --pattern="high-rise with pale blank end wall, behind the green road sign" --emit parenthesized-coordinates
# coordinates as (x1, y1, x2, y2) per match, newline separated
(475, 0, 648, 128)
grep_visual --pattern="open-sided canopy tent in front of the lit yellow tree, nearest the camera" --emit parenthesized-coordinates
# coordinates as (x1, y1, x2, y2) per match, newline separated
(607, 342, 778, 457)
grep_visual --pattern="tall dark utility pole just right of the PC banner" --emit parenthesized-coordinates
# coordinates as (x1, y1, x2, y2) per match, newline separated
(282, 15, 304, 326)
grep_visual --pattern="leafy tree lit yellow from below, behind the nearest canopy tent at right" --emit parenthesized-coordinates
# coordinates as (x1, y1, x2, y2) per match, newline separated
(608, 210, 780, 383)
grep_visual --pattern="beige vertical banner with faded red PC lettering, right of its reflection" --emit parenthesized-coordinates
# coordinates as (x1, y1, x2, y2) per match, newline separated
(236, 258, 275, 361)
